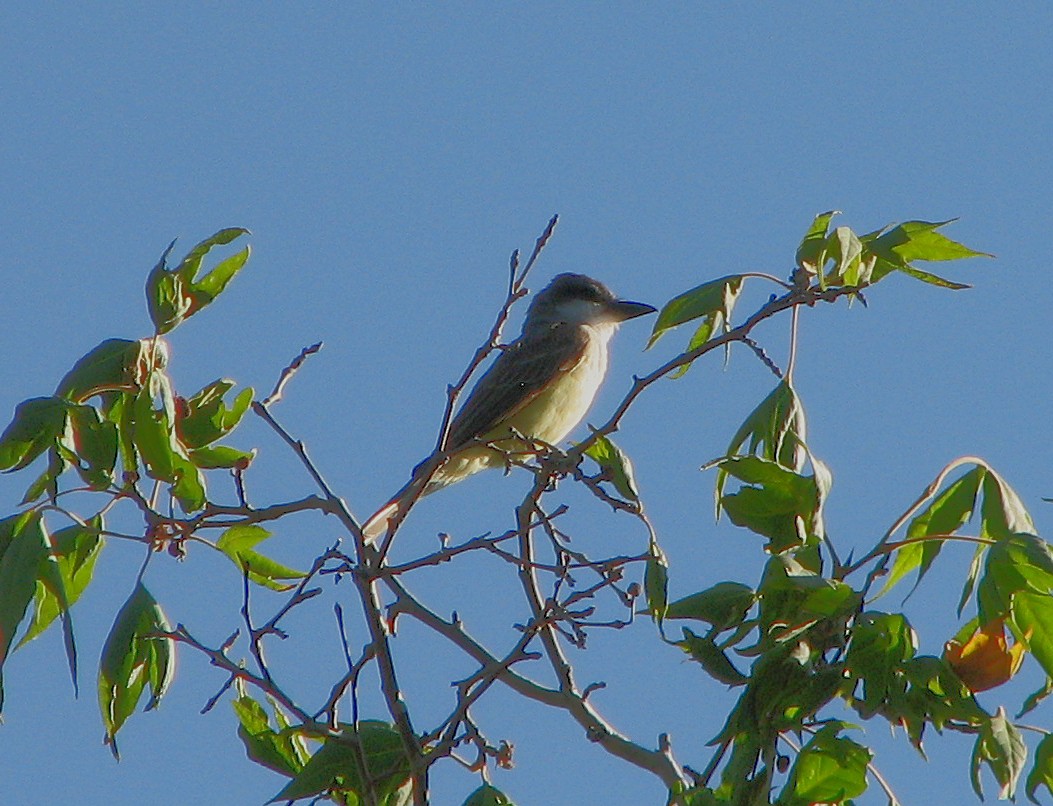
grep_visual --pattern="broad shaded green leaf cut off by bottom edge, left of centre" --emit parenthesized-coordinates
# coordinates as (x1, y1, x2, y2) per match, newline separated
(269, 721, 410, 803)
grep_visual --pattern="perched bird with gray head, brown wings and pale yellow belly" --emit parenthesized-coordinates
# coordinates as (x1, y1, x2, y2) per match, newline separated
(362, 273, 657, 543)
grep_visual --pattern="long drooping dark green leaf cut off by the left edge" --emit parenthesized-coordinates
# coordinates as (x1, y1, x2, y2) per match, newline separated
(0, 510, 47, 710)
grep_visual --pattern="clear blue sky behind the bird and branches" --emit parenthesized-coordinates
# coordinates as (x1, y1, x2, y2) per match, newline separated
(0, 3, 1053, 806)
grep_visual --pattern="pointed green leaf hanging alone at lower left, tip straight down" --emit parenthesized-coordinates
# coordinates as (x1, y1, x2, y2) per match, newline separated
(99, 582, 176, 758)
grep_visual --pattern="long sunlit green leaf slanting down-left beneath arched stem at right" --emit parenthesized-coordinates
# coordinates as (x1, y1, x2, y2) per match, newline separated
(877, 467, 986, 596)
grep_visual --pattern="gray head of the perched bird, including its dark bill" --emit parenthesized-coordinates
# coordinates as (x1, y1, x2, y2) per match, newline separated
(523, 274, 655, 331)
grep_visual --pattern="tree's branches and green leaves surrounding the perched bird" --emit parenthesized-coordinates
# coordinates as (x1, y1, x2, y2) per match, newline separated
(0, 213, 1053, 806)
